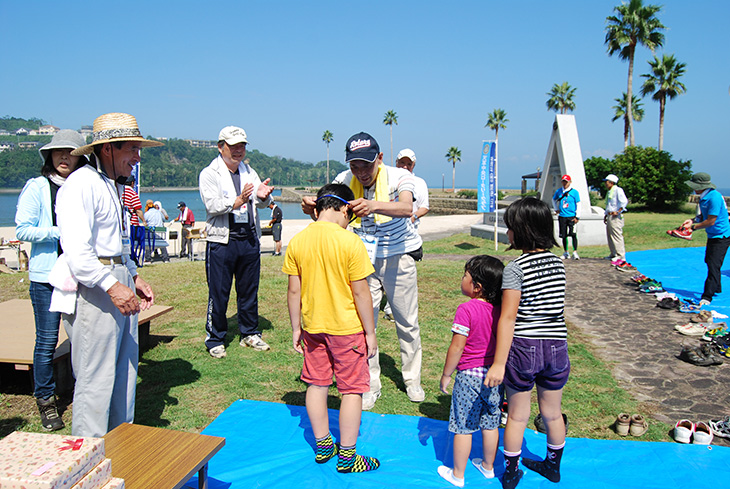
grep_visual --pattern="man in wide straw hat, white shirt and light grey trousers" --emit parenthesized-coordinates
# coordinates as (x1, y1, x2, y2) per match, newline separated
(56, 113, 162, 437)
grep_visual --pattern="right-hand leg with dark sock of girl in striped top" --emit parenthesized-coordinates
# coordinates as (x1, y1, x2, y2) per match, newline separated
(522, 387, 565, 482)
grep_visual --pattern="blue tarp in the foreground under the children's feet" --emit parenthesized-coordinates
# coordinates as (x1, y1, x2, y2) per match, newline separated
(187, 400, 730, 489)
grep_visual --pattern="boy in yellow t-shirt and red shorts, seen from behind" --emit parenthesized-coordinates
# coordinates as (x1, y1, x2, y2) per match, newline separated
(282, 184, 380, 472)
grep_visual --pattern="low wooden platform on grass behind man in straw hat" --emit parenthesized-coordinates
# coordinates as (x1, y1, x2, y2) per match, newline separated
(0, 299, 172, 370)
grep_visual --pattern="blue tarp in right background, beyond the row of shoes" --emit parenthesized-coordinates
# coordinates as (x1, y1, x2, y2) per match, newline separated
(626, 247, 730, 315)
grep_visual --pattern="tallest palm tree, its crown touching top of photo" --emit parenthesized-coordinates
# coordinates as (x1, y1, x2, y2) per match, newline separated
(605, 0, 665, 146)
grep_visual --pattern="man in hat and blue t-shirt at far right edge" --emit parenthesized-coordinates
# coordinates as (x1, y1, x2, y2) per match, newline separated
(682, 172, 730, 306)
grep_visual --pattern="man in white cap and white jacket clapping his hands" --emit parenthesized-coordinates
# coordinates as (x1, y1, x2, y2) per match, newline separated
(200, 126, 274, 358)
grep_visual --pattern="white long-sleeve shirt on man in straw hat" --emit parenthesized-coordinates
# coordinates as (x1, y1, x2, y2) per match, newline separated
(56, 165, 137, 292)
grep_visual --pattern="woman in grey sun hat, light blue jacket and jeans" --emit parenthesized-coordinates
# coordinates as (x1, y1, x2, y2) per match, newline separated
(15, 129, 87, 431)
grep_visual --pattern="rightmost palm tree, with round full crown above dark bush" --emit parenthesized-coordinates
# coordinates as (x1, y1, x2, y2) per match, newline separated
(641, 54, 687, 151)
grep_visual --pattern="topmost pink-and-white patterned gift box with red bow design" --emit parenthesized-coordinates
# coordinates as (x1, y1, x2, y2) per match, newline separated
(0, 431, 105, 489)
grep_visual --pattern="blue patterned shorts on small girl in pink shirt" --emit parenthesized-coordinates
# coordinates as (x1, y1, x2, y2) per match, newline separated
(449, 371, 502, 435)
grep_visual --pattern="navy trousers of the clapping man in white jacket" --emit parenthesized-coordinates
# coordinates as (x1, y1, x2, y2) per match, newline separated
(205, 237, 261, 349)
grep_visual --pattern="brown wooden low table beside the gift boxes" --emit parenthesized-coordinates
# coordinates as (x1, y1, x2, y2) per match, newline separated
(104, 423, 226, 489)
